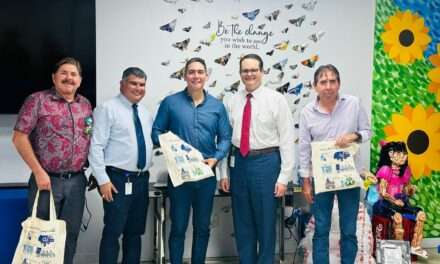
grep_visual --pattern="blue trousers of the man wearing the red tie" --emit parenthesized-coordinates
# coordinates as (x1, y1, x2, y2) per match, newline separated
(230, 151, 281, 264)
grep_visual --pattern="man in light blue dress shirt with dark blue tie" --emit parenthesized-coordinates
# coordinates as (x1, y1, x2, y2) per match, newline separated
(89, 67, 153, 264)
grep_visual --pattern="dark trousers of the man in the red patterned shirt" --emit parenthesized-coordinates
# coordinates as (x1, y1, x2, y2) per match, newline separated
(28, 174, 87, 264)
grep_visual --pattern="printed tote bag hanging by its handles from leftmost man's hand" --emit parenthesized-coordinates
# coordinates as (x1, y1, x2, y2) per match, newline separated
(12, 191, 66, 264)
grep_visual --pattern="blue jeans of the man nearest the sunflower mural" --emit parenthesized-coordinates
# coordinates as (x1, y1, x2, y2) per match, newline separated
(312, 187, 360, 264)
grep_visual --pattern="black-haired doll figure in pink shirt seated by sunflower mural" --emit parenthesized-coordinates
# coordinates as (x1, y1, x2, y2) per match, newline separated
(373, 141, 428, 258)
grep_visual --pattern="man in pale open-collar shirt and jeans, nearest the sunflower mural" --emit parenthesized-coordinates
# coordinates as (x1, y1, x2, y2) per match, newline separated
(298, 64, 371, 264)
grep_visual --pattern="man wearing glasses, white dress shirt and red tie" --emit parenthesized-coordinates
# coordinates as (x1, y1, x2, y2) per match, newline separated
(221, 54, 295, 264)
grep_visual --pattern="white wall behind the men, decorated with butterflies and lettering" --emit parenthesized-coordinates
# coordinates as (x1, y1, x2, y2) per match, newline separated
(0, 0, 374, 263)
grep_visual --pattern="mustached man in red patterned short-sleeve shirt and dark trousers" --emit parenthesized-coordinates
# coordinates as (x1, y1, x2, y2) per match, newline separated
(12, 58, 92, 264)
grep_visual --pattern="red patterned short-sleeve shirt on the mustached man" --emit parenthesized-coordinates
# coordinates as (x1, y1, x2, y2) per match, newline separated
(14, 88, 92, 173)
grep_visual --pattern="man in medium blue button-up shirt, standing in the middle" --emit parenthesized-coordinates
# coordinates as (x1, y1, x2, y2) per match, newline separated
(152, 58, 231, 264)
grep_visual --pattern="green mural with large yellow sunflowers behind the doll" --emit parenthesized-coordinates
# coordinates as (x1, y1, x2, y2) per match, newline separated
(370, 0, 440, 238)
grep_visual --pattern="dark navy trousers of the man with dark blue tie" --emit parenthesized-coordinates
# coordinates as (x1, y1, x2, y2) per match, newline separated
(99, 169, 150, 264)
